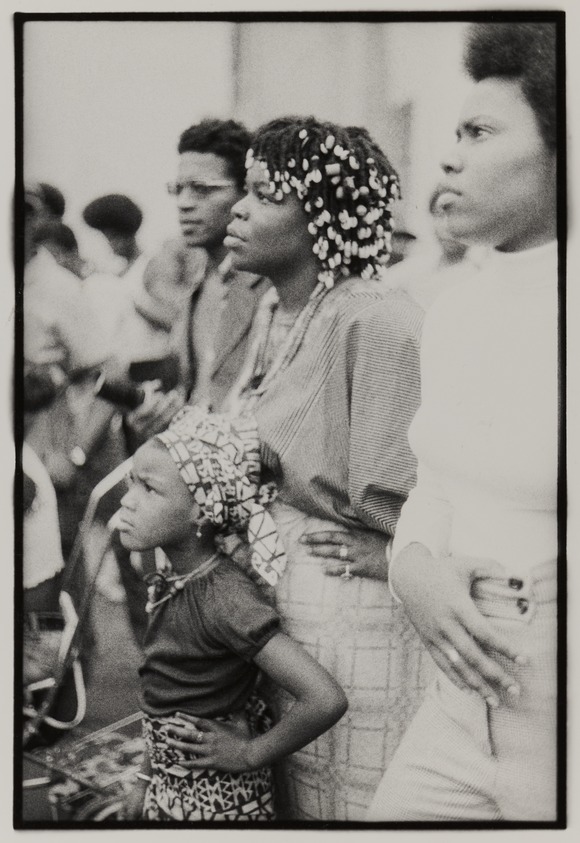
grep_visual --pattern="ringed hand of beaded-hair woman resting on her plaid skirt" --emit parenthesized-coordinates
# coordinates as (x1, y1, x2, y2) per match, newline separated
(300, 530, 390, 582)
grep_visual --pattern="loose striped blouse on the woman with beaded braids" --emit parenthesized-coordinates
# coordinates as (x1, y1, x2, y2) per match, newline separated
(255, 278, 423, 535)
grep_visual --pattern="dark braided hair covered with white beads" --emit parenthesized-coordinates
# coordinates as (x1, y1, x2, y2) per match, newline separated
(246, 117, 400, 289)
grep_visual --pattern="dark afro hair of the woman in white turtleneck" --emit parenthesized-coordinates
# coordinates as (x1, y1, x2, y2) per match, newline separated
(464, 23, 557, 149)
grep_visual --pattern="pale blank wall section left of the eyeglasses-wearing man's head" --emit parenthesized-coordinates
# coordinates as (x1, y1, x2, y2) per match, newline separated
(24, 21, 233, 260)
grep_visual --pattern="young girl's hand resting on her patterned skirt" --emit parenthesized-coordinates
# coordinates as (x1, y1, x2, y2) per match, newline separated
(166, 713, 253, 773)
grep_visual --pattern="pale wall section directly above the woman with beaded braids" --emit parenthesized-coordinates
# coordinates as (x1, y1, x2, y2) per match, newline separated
(235, 22, 466, 244)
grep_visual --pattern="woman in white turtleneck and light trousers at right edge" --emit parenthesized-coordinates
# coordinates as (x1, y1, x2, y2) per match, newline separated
(368, 24, 558, 821)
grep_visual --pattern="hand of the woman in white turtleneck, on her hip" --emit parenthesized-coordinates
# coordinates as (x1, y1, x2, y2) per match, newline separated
(391, 543, 526, 708)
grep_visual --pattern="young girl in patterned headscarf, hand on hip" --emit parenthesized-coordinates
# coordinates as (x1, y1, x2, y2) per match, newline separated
(119, 407, 347, 820)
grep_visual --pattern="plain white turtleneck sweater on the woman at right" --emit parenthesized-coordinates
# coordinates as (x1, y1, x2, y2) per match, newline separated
(393, 242, 558, 576)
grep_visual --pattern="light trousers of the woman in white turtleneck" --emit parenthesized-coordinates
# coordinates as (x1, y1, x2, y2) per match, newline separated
(367, 562, 557, 822)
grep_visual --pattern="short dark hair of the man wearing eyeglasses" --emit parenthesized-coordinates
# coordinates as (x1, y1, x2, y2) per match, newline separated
(177, 118, 251, 190)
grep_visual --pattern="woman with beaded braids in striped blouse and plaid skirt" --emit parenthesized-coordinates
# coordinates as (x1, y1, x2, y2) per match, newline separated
(193, 117, 428, 820)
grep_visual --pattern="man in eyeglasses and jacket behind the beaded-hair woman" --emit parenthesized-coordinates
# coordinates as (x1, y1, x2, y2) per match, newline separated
(128, 119, 269, 440)
